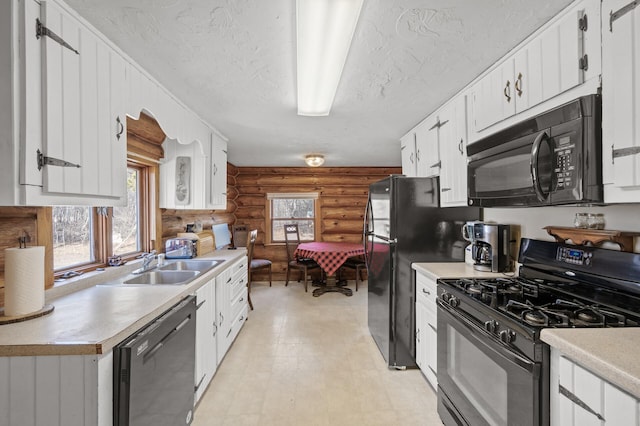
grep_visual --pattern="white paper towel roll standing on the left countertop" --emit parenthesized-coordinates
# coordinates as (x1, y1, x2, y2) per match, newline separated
(4, 247, 44, 317)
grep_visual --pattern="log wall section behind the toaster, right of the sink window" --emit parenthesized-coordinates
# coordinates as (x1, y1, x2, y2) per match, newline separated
(158, 163, 238, 248)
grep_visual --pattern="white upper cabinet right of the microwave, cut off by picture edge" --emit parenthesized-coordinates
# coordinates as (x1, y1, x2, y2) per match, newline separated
(602, 0, 640, 203)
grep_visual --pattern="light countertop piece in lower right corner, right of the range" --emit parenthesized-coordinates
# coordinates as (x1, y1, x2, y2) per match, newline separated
(540, 327, 640, 399)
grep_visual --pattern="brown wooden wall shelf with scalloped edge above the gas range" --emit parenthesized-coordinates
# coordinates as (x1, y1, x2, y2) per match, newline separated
(544, 226, 640, 252)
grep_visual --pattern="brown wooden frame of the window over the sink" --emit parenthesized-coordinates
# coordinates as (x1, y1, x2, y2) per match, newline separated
(52, 158, 158, 278)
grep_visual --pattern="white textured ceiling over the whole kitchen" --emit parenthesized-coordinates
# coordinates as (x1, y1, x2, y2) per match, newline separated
(66, 0, 570, 167)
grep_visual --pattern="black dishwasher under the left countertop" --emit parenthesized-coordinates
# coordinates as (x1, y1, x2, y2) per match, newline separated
(113, 296, 196, 426)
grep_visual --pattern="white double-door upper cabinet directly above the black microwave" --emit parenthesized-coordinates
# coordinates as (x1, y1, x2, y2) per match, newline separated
(471, 0, 601, 140)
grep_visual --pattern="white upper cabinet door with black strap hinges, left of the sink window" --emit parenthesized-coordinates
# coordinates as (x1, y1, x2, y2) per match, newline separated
(39, 2, 127, 205)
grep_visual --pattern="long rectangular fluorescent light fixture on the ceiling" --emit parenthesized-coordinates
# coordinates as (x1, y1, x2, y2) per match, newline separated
(296, 0, 364, 116)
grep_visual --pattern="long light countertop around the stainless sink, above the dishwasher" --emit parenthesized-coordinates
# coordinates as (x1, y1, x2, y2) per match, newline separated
(0, 249, 246, 356)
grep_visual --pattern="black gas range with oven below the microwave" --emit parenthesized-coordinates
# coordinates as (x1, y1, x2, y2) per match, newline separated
(438, 239, 640, 425)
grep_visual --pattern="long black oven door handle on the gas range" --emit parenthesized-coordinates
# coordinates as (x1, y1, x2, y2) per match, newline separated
(436, 299, 540, 377)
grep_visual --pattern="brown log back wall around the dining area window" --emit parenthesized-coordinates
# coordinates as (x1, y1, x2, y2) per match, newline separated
(235, 167, 402, 281)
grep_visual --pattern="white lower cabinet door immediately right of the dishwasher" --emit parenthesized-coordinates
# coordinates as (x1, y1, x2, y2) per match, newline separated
(195, 278, 218, 403)
